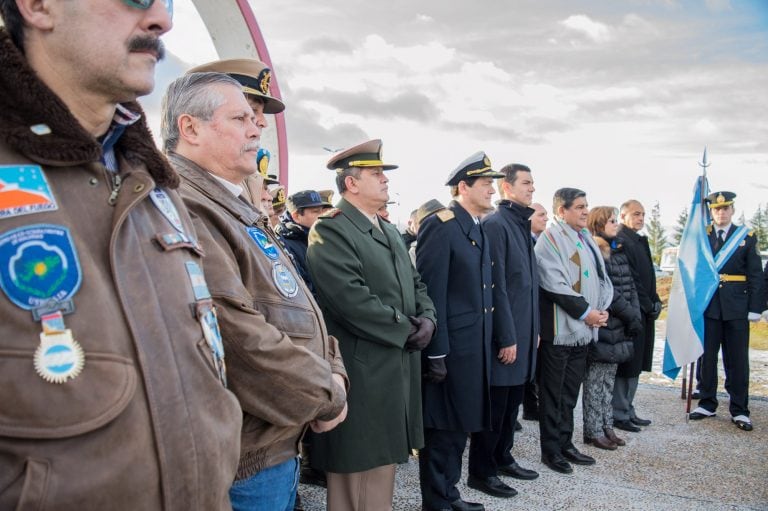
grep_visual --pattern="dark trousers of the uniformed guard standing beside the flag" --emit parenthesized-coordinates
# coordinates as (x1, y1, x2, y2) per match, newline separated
(699, 318, 749, 417)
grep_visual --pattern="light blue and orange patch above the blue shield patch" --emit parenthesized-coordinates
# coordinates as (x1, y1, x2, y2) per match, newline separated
(0, 165, 59, 218)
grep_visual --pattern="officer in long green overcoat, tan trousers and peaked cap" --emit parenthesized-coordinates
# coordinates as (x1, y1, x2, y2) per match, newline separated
(307, 140, 435, 511)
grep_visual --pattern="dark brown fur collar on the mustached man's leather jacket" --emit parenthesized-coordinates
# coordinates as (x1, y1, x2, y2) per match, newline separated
(0, 28, 179, 188)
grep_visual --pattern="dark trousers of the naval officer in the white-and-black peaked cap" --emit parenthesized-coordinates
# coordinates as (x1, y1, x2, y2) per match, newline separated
(419, 428, 467, 509)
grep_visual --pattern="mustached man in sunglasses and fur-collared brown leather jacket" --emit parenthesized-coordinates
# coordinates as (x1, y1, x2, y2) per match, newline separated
(0, 0, 242, 510)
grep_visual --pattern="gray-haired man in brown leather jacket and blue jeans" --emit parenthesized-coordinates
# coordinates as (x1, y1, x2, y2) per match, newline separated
(162, 73, 346, 511)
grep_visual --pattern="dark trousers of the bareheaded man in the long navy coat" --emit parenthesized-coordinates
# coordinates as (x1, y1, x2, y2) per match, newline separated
(469, 385, 525, 479)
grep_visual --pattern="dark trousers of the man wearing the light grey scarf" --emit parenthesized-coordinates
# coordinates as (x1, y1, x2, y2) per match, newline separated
(539, 342, 589, 456)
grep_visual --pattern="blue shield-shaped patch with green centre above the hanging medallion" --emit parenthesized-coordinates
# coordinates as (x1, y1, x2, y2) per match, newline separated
(0, 224, 82, 310)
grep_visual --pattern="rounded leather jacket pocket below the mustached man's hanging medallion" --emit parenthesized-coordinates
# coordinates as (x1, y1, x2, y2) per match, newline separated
(0, 350, 137, 439)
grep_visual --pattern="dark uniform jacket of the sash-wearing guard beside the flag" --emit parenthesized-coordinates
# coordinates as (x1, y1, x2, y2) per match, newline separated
(704, 224, 765, 321)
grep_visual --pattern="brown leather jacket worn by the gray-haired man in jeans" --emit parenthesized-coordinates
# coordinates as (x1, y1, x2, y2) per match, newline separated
(168, 153, 346, 479)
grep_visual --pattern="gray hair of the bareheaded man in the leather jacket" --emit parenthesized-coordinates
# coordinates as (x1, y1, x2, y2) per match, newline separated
(160, 73, 242, 152)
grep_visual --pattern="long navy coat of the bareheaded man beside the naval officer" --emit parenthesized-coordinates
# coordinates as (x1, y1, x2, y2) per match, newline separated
(483, 200, 539, 386)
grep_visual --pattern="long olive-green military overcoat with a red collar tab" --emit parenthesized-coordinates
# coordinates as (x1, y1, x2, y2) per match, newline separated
(307, 199, 435, 473)
